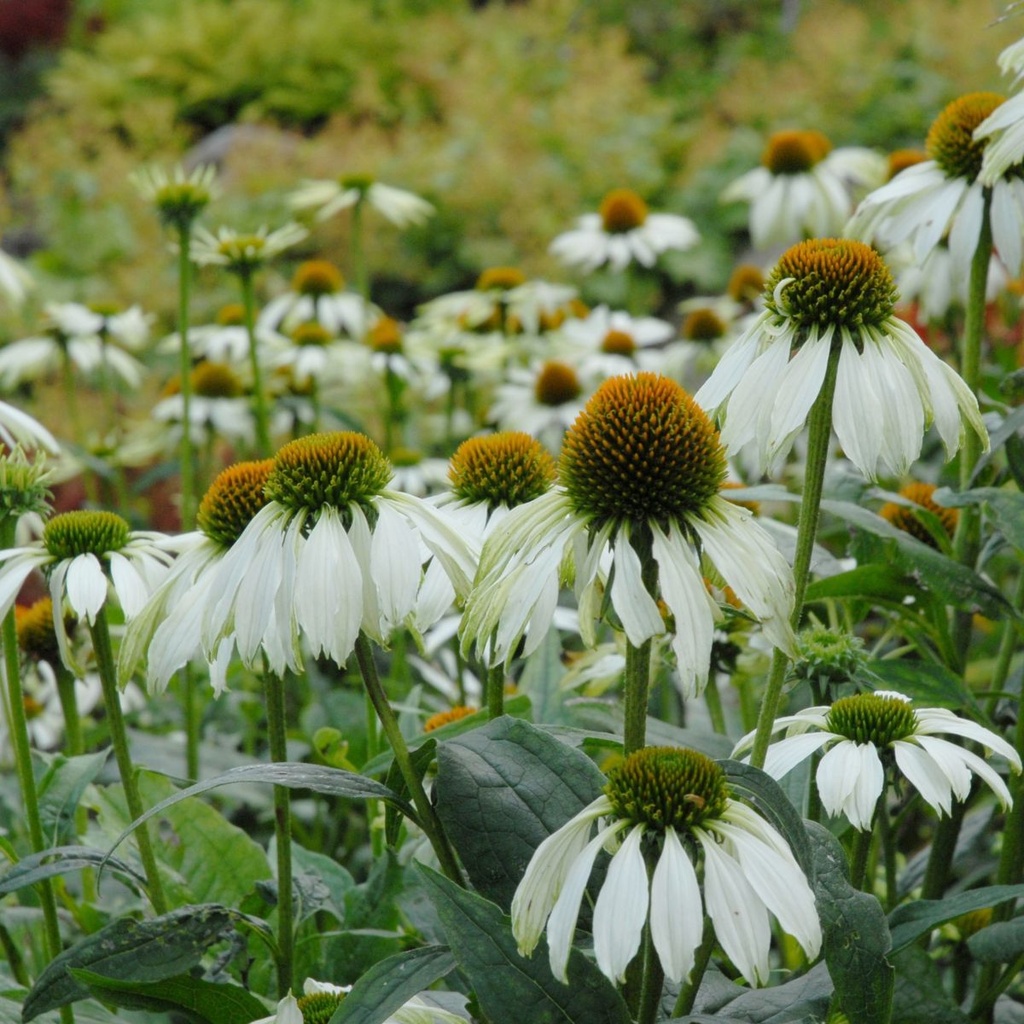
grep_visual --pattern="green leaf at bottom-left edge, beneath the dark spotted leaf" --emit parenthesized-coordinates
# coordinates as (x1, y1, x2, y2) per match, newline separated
(71, 969, 267, 1024)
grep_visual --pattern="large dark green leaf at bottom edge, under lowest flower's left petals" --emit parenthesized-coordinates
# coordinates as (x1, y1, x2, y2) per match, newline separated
(417, 864, 631, 1024)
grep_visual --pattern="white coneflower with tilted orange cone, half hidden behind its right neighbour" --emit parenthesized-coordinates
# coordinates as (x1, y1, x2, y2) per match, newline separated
(118, 459, 273, 695)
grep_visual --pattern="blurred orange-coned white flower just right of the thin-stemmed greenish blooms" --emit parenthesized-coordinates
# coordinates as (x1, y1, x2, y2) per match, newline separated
(257, 259, 381, 340)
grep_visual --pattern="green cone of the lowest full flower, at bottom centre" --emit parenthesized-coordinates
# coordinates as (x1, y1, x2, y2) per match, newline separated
(604, 746, 729, 831)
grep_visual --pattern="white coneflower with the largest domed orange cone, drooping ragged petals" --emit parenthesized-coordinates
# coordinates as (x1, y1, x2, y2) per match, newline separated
(463, 373, 794, 694)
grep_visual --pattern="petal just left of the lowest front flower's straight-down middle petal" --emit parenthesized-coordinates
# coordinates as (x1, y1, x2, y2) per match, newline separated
(593, 822, 649, 982)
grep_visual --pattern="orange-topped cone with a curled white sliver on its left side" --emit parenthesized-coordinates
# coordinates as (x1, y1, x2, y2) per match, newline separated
(765, 239, 897, 330)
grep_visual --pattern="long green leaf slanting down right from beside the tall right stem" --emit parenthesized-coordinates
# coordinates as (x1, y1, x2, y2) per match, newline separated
(821, 500, 1015, 618)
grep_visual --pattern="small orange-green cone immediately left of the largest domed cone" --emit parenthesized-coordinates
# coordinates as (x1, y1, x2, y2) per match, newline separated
(449, 430, 555, 509)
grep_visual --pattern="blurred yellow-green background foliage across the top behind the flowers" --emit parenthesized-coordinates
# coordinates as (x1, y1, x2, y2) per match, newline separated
(0, 0, 1024, 325)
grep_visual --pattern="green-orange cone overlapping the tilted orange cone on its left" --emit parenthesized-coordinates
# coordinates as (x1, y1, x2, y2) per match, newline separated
(266, 431, 391, 513)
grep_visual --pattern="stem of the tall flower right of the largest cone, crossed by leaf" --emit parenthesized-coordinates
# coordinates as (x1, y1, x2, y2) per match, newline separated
(751, 344, 840, 768)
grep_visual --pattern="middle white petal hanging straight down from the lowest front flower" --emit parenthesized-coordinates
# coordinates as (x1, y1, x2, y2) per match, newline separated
(650, 825, 703, 985)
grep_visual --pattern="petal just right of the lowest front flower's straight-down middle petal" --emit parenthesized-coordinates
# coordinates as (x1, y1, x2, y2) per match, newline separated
(693, 828, 771, 985)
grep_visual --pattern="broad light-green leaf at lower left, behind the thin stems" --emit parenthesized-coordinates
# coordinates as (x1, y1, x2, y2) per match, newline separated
(139, 773, 271, 906)
